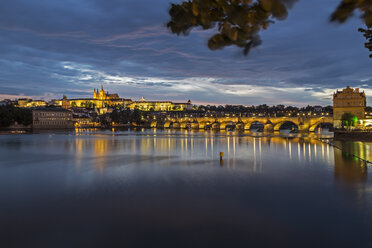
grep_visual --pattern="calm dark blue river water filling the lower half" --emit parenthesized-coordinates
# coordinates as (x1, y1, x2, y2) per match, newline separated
(0, 130, 372, 248)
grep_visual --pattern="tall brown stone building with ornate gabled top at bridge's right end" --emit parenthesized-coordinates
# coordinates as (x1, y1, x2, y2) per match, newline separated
(333, 86, 366, 127)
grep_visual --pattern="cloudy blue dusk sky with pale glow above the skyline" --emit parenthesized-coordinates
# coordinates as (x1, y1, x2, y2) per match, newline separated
(0, 0, 372, 106)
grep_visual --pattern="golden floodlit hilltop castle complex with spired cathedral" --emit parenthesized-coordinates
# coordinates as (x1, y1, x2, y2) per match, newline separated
(56, 85, 192, 113)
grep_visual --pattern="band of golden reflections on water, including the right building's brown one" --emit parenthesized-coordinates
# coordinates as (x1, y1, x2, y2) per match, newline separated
(73, 130, 372, 186)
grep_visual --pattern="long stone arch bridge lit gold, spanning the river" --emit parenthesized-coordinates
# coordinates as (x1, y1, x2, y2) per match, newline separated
(151, 117, 333, 132)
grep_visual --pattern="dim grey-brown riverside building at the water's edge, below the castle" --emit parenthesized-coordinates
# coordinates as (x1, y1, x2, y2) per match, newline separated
(32, 108, 74, 129)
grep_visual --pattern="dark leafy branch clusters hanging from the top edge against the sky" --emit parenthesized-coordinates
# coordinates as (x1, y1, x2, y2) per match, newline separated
(167, 0, 372, 57)
